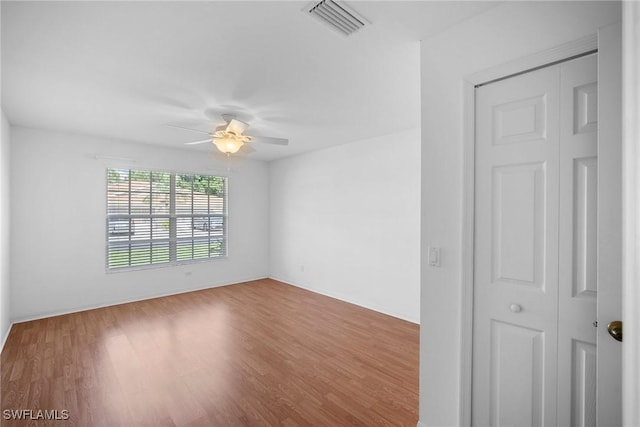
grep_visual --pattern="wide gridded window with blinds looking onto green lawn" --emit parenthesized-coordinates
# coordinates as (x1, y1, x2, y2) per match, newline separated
(107, 169, 227, 270)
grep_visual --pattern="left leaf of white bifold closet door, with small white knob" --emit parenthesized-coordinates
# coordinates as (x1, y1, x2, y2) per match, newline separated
(472, 63, 560, 426)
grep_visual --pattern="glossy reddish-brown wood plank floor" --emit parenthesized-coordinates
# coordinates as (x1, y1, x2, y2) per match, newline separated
(0, 280, 419, 427)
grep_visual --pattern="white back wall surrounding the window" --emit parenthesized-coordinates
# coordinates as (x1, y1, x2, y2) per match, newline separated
(10, 127, 269, 321)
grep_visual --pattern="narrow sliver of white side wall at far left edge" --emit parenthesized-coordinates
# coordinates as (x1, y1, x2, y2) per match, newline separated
(0, 112, 11, 350)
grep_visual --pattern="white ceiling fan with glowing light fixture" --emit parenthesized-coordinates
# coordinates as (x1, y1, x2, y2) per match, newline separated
(168, 114, 289, 156)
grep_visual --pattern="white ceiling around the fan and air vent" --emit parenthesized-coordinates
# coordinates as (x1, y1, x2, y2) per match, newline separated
(1, 1, 495, 161)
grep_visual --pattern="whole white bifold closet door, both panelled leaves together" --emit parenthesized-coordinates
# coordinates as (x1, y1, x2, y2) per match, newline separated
(472, 49, 619, 426)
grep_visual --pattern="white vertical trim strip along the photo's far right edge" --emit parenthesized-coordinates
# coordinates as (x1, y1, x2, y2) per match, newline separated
(622, 1, 640, 426)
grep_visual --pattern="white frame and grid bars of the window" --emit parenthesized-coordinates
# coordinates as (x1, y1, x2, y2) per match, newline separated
(104, 166, 229, 273)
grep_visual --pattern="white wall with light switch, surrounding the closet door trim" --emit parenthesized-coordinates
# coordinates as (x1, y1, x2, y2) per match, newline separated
(420, 2, 620, 426)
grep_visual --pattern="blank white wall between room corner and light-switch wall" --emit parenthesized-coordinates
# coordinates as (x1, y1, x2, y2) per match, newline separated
(269, 130, 420, 323)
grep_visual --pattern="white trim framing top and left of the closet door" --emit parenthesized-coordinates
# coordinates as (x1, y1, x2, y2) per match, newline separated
(459, 34, 598, 427)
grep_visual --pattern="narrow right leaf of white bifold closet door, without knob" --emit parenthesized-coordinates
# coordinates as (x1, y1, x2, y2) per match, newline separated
(558, 55, 598, 426)
